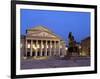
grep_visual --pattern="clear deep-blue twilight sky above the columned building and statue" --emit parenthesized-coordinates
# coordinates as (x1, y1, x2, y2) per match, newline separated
(21, 9, 90, 42)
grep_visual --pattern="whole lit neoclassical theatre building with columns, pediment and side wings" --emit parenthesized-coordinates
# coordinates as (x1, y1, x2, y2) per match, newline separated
(21, 26, 66, 58)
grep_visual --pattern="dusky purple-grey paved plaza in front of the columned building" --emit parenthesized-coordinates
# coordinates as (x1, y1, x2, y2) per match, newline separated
(21, 57, 90, 69)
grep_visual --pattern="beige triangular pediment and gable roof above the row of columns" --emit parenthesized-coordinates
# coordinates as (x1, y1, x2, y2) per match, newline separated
(27, 26, 59, 38)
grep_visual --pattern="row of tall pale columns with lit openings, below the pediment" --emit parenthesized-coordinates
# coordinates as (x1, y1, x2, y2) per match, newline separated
(25, 39, 60, 56)
